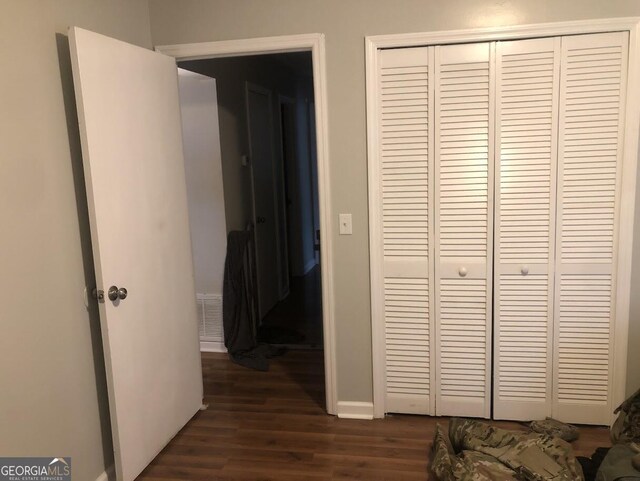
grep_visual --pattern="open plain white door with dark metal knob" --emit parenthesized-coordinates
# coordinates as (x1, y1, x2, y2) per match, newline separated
(69, 27, 202, 481)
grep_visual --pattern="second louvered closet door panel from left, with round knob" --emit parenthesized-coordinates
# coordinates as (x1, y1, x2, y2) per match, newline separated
(435, 43, 494, 417)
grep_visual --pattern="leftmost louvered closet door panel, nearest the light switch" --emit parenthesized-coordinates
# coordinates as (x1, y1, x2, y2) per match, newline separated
(378, 48, 435, 414)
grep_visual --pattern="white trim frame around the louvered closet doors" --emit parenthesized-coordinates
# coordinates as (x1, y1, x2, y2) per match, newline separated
(365, 17, 640, 421)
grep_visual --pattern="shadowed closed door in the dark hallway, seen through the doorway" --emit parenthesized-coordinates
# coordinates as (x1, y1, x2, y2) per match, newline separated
(247, 84, 280, 319)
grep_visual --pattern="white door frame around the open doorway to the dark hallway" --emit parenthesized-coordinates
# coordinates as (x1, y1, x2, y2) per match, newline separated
(156, 33, 337, 414)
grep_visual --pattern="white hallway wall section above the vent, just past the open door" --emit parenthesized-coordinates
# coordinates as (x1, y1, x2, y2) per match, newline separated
(178, 69, 227, 294)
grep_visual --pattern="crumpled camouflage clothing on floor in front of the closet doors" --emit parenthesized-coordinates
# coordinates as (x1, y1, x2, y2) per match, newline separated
(431, 418, 584, 481)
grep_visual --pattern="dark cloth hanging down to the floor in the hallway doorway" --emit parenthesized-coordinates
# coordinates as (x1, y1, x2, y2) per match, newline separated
(222, 231, 282, 371)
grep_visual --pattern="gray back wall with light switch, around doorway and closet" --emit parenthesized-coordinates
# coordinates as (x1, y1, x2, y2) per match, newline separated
(149, 0, 640, 401)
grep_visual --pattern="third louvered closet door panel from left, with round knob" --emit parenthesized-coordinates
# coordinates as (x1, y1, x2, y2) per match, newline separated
(493, 38, 560, 420)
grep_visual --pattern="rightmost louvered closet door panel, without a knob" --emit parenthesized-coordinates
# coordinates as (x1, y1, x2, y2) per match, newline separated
(553, 33, 628, 424)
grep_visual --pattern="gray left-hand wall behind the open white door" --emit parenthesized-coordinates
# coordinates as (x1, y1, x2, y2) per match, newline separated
(0, 0, 151, 481)
